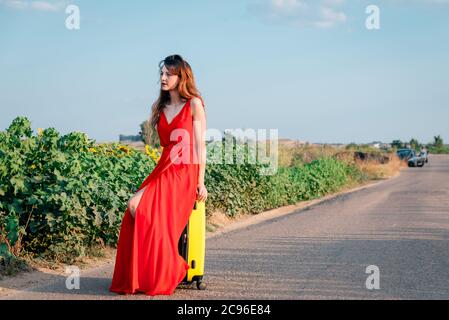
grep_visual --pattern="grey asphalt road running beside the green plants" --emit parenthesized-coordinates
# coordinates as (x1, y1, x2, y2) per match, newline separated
(0, 156, 449, 299)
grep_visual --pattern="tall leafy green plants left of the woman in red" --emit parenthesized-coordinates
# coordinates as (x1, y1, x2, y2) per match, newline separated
(0, 117, 156, 269)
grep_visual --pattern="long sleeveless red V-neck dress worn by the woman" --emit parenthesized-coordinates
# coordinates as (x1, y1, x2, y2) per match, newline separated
(109, 100, 199, 296)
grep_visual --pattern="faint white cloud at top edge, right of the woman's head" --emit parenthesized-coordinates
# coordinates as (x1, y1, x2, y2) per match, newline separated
(247, 0, 347, 28)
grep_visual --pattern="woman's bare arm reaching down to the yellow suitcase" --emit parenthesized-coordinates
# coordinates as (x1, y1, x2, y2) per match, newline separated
(190, 98, 207, 200)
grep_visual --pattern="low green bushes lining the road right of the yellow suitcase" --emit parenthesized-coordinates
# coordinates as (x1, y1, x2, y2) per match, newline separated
(206, 141, 366, 216)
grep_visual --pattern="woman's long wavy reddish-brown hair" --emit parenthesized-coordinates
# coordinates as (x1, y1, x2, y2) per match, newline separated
(150, 54, 205, 132)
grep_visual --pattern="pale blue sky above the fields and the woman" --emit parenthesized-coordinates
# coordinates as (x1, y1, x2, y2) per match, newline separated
(0, 0, 449, 143)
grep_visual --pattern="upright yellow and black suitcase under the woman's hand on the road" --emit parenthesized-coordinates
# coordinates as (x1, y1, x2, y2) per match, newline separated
(178, 200, 206, 290)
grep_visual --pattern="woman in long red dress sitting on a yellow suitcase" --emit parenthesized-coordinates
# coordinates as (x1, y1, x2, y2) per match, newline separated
(109, 55, 207, 296)
